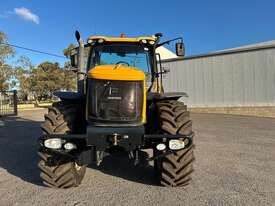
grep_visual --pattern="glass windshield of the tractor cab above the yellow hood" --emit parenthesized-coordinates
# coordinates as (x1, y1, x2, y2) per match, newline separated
(89, 43, 151, 74)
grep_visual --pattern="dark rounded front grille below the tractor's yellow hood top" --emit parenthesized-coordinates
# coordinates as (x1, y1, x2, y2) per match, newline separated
(89, 79, 143, 123)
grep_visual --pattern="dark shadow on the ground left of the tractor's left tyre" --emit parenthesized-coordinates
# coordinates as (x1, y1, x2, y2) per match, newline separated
(0, 116, 41, 185)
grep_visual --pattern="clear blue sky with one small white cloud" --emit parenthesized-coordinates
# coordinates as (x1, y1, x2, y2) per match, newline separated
(0, 0, 275, 64)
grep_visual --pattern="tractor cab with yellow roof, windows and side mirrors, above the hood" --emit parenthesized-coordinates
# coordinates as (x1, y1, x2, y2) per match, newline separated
(71, 33, 185, 93)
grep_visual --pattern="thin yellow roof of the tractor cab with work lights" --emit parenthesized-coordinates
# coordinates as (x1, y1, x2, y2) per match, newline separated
(88, 36, 157, 43)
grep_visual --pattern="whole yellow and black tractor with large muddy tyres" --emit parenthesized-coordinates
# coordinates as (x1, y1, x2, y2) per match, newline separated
(38, 31, 194, 188)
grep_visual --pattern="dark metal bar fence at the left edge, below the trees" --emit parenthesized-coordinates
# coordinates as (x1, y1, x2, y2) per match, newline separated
(0, 90, 17, 116)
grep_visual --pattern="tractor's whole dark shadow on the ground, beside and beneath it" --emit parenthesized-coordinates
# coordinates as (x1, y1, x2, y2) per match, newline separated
(0, 113, 157, 185)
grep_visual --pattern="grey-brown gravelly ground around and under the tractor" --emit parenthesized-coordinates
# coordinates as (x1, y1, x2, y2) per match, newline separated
(0, 110, 275, 206)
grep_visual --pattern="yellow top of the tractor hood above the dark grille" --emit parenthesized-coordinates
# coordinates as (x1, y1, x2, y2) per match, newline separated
(88, 64, 145, 81)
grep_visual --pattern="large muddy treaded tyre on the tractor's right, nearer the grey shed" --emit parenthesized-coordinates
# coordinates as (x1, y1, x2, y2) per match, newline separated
(154, 100, 194, 187)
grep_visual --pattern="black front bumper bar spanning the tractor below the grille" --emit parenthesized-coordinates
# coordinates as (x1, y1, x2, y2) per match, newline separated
(39, 126, 194, 151)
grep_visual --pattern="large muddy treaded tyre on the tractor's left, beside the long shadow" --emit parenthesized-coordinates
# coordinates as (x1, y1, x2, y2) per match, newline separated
(38, 102, 86, 188)
